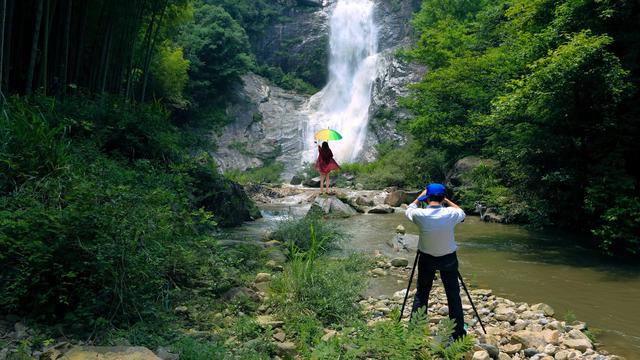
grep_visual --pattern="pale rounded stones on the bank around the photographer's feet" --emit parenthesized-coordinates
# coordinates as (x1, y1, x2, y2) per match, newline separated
(360, 256, 621, 360)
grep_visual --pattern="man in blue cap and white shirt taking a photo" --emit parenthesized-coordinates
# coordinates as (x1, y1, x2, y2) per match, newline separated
(405, 183, 466, 340)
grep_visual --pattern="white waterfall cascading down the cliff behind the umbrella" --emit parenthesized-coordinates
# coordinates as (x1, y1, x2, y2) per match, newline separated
(302, 0, 378, 162)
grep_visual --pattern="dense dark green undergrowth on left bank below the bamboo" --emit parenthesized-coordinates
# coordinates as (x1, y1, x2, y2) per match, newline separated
(0, 97, 256, 327)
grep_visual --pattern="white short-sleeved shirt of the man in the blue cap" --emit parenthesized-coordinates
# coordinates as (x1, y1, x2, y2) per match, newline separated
(405, 204, 465, 256)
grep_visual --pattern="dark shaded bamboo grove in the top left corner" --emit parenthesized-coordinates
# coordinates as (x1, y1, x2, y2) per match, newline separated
(0, 0, 187, 101)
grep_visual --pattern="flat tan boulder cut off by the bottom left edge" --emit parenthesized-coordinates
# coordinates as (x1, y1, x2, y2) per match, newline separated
(62, 346, 162, 360)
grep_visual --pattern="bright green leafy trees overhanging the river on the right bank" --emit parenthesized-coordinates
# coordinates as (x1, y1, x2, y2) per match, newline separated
(404, 0, 640, 254)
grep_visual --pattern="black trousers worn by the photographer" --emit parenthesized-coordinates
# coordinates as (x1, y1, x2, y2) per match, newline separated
(411, 251, 466, 340)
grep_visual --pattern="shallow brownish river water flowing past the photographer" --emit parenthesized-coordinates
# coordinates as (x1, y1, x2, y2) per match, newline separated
(225, 205, 640, 360)
